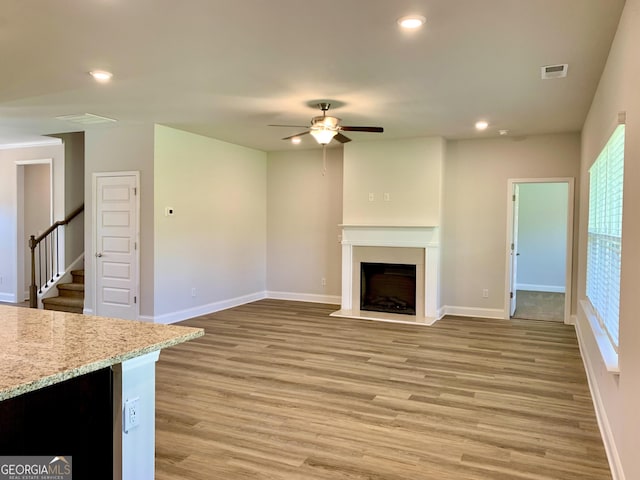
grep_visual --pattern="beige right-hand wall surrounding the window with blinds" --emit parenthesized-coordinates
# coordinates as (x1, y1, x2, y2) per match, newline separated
(577, 0, 640, 480)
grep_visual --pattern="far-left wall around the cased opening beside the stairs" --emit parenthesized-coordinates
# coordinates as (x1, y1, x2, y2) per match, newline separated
(0, 145, 64, 302)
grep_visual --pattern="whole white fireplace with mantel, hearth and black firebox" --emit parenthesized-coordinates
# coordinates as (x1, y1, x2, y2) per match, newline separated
(331, 225, 441, 325)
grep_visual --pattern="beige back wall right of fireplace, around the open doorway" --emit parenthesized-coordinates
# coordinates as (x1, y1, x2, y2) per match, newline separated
(441, 133, 580, 318)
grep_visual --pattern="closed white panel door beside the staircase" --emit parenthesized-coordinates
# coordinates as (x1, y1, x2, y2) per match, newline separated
(94, 173, 139, 320)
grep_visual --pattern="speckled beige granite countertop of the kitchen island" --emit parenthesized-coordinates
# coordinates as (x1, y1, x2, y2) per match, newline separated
(0, 305, 204, 401)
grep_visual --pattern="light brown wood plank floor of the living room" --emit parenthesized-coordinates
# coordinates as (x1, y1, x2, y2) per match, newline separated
(156, 300, 611, 480)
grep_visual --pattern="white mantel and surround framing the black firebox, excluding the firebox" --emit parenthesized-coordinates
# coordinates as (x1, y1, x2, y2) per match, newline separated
(332, 225, 440, 325)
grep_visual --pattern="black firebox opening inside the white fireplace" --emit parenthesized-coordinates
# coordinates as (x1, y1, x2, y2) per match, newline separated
(360, 262, 416, 315)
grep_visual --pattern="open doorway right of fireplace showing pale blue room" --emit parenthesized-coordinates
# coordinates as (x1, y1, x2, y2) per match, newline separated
(505, 178, 574, 323)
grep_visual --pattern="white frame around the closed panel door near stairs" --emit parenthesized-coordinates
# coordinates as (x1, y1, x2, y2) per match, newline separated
(92, 171, 141, 319)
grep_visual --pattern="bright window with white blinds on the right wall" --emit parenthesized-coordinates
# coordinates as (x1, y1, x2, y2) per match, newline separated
(587, 125, 625, 352)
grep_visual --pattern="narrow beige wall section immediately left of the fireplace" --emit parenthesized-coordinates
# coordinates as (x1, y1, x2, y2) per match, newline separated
(267, 148, 343, 303)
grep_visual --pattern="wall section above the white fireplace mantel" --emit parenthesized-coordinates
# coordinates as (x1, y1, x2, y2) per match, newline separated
(343, 137, 445, 226)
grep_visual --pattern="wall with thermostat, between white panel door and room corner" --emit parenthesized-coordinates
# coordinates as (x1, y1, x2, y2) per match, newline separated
(153, 125, 267, 323)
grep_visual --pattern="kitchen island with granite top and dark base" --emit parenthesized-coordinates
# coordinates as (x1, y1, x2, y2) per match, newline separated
(0, 305, 204, 480)
